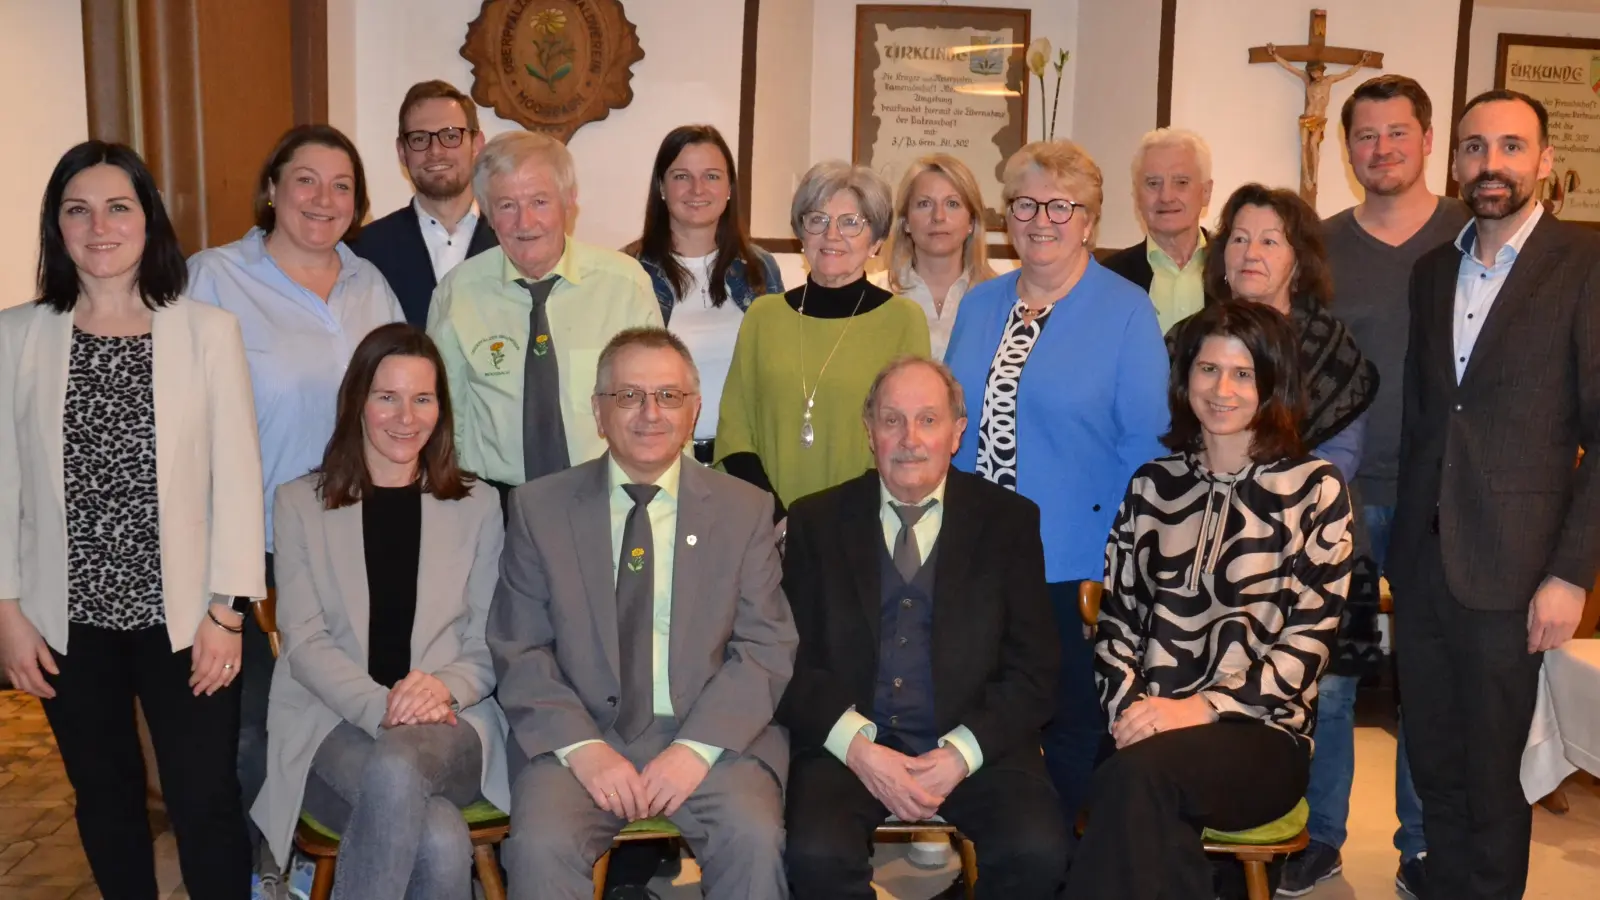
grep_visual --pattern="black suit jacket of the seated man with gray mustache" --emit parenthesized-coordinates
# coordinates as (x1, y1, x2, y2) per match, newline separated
(778, 469, 1061, 773)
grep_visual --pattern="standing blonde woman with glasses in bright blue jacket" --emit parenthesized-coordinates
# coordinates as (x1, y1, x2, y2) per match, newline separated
(944, 141, 1168, 822)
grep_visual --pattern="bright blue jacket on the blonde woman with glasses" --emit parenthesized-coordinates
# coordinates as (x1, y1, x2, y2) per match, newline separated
(944, 259, 1168, 583)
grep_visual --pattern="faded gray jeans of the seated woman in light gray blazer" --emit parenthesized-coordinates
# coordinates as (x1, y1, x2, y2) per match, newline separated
(304, 722, 483, 900)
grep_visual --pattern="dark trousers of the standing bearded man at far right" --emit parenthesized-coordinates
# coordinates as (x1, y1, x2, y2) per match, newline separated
(1395, 538, 1544, 900)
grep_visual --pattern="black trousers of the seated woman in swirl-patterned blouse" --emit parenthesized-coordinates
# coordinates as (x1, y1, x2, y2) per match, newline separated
(1062, 713, 1312, 900)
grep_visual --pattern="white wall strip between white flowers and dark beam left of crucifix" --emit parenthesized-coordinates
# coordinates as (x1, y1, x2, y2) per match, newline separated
(1075, 0, 1164, 247)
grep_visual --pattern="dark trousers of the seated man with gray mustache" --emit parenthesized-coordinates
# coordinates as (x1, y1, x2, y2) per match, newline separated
(784, 743, 1067, 900)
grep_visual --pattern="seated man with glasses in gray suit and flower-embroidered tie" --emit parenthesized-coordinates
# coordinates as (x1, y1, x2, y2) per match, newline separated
(488, 328, 797, 900)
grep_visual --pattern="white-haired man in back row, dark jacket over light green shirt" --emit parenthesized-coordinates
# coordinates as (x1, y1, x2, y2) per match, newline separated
(1106, 128, 1211, 335)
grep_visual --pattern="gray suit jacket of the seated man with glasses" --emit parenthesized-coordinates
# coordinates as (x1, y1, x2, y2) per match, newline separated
(488, 456, 797, 783)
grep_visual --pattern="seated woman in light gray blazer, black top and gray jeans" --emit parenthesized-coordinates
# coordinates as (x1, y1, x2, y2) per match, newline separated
(251, 323, 510, 900)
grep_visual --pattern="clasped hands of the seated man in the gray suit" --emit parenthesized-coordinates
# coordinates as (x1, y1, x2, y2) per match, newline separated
(566, 741, 710, 822)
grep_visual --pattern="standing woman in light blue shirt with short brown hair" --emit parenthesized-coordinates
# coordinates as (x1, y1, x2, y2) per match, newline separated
(189, 125, 405, 876)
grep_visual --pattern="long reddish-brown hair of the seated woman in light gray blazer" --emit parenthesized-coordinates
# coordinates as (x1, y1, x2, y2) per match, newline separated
(317, 322, 477, 509)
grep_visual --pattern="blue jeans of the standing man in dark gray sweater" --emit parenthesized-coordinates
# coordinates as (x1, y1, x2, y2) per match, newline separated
(1306, 506, 1427, 860)
